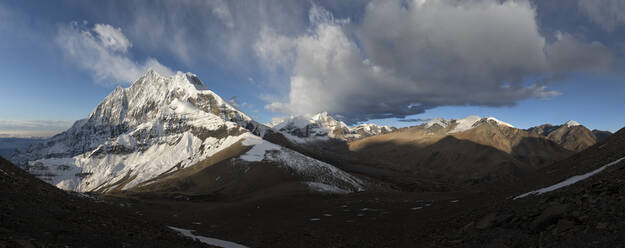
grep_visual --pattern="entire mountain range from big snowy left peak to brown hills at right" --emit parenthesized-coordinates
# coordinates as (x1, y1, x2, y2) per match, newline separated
(11, 71, 610, 197)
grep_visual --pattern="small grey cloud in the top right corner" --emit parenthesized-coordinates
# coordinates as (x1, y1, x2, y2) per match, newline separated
(578, 0, 625, 32)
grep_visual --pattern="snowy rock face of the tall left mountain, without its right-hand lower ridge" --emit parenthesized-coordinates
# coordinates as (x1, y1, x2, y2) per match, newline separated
(13, 70, 264, 191)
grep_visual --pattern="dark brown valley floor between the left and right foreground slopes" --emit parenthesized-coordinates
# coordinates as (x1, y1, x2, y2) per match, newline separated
(106, 193, 498, 247)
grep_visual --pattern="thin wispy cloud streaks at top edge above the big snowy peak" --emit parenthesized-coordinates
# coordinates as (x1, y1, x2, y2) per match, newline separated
(125, 0, 308, 70)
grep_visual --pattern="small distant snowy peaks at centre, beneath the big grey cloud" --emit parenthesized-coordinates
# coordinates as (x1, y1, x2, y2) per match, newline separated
(272, 112, 397, 143)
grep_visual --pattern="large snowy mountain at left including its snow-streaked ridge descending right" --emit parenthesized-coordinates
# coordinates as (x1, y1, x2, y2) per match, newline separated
(12, 70, 362, 192)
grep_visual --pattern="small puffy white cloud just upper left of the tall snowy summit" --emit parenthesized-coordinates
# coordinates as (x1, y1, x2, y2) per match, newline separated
(55, 22, 174, 84)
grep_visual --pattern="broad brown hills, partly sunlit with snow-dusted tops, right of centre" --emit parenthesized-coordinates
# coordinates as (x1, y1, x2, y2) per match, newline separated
(349, 116, 573, 187)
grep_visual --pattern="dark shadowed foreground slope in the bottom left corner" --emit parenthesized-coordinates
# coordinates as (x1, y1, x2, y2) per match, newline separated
(0, 158, 206, 247)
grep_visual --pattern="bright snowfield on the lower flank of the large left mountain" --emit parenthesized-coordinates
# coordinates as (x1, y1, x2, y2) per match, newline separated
(29, 131, 247, 192)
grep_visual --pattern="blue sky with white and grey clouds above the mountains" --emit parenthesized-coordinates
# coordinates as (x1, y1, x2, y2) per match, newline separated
(0, 0, 625, 136)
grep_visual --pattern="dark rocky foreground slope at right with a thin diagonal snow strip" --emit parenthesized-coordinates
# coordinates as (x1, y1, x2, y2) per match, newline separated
(432, 129, 625, 247)
